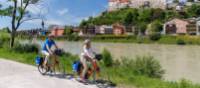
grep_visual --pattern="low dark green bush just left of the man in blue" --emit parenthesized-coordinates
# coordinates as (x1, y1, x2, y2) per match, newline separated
(12, 43, 39, 53)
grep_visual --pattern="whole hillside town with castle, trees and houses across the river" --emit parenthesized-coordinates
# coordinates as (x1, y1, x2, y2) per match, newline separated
(18, 0, 200, 37)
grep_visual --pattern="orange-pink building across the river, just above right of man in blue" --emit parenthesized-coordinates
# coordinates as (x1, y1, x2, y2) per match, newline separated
(50, 26, 65, 37)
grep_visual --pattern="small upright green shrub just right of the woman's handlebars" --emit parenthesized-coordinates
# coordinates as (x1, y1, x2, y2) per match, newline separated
(102, 49, 113, 67)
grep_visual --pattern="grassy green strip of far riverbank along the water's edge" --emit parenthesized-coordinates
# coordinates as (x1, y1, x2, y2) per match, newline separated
(18, 35, 200, 45)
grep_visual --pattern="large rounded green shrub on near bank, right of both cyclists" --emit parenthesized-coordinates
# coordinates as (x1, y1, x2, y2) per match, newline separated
(132, 56, 164, 78)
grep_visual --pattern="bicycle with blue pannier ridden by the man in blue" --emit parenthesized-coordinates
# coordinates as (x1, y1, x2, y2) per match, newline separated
(35, 49, 62, 75)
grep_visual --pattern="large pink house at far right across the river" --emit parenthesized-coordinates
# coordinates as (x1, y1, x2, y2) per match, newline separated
(163, 18, 199, 35)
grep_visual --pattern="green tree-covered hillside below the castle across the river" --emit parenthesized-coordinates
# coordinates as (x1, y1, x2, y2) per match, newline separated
(80, 0, 200, 35)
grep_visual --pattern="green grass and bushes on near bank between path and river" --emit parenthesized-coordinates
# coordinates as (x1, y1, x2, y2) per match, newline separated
(0, 33, 200, 88)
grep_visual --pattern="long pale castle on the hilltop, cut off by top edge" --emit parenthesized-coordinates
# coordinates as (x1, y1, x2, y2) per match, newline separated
(108, 0, 170, 11)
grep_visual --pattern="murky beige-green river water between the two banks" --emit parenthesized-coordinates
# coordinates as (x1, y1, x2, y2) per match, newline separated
(26, 41, 200, 83)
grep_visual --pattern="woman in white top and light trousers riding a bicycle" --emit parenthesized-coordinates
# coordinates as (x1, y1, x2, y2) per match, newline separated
(80, 39, 96, 82)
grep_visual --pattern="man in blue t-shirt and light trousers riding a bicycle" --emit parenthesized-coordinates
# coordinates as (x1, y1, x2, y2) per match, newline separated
(42, 35, 58, 67)
